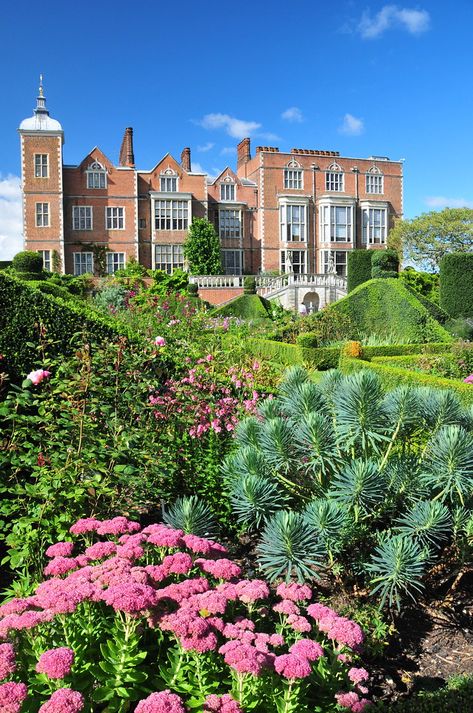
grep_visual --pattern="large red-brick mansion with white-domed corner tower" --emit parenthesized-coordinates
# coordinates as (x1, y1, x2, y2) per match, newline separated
(19, 80, 403, 275)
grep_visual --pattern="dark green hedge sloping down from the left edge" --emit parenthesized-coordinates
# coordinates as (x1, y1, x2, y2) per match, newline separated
(0, 273, 138, 380)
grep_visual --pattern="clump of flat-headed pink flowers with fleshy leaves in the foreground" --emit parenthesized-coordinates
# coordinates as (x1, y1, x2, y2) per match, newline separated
(0, 517, 369, 713)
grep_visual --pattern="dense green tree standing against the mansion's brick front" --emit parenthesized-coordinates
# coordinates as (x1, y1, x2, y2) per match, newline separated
(184, 218, 221, 275)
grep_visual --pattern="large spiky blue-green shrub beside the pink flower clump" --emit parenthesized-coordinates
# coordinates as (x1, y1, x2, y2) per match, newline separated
(224, 368, 473, 607)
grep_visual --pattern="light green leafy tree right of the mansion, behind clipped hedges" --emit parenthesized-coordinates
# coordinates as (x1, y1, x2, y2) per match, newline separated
(389, 208, 473, 270)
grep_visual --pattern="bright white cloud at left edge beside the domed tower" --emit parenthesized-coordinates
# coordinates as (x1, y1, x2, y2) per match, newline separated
(0, 174, 23, 260)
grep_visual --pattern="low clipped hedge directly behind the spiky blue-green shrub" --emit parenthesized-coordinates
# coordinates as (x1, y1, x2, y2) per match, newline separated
(339, 354, 473, 406)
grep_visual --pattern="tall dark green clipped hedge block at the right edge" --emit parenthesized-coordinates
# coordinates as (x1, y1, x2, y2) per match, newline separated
(440, 253, 473, 317)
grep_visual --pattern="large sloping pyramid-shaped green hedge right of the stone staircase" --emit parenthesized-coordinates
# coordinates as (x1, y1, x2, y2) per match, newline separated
(324, 279, 452, 344)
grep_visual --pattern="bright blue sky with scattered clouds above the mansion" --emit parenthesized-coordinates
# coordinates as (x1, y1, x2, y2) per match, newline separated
(0, 0, 473, 259)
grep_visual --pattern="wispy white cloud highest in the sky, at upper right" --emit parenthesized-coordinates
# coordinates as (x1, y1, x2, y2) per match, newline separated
(357, 5, 430, 40)
